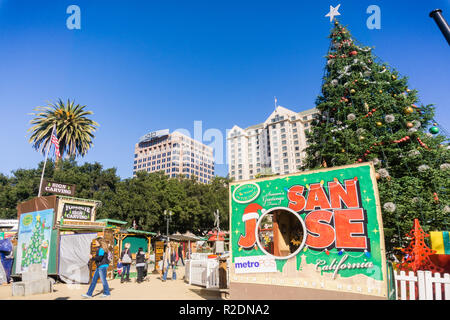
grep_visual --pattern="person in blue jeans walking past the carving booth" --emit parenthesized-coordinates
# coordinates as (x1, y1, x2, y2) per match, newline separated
(81, 238, 111, 298)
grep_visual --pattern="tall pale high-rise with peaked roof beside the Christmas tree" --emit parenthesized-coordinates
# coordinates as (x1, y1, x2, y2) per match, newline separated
(227, 106, 318, 181)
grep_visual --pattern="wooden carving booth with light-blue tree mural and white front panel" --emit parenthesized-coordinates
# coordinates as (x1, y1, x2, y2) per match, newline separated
(12, 195, 117, 283)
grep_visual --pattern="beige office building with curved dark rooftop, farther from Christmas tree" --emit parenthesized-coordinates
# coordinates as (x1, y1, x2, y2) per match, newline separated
(133, 129, 214, 183)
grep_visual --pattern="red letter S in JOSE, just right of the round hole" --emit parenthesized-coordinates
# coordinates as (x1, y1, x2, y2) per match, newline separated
(305, 210, 334, 249)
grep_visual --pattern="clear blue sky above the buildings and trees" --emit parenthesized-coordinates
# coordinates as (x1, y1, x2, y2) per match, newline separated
(0, 0, 450, 178)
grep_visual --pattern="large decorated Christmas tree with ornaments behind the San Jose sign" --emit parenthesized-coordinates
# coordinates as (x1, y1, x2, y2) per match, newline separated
(302, 21, 450, 255)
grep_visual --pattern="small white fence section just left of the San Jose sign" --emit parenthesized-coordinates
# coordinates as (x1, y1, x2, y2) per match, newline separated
(185, 257, 229, 289)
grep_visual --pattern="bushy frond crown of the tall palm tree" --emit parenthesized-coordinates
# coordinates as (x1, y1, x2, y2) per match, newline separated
(28, 99, 99, 157)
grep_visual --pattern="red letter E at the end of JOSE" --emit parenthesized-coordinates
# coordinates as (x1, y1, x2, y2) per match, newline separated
(334, 209, 368, 249)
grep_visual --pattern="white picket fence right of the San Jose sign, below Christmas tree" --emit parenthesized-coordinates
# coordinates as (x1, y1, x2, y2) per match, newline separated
(394, 271, 450, 300)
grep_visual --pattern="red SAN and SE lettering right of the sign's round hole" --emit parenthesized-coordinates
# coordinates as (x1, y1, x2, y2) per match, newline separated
(287, 178, 369, 251)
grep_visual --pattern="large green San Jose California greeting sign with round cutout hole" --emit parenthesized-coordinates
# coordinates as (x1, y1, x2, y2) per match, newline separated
(230, 164, 387, 297)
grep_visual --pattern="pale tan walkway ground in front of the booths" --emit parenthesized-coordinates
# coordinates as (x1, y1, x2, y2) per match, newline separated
(0, 267, 220, 300)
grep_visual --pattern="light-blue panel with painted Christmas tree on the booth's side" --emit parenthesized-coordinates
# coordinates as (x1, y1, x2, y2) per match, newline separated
(16, 209, 54, 274)
